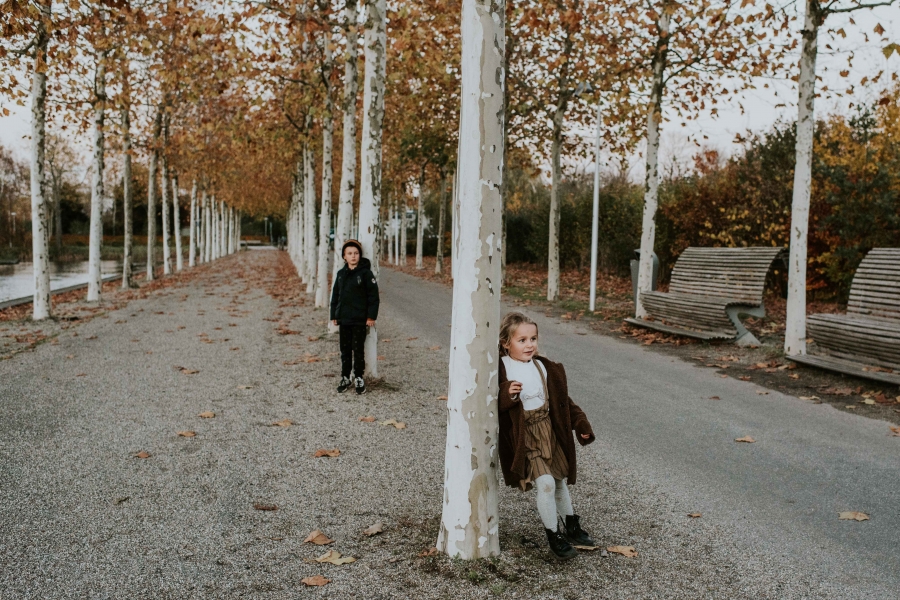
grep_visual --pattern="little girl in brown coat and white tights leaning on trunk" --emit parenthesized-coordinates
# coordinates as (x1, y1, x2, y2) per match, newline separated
(499, 312, 595, 560)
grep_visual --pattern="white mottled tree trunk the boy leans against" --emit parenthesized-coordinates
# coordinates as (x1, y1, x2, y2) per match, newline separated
(359, 0, 387, 377)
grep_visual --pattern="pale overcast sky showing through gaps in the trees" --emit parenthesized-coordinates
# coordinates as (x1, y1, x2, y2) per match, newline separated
(0, 4, 900, 178)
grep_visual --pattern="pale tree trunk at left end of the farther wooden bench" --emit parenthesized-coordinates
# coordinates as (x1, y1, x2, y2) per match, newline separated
(634, 11, 669, 318)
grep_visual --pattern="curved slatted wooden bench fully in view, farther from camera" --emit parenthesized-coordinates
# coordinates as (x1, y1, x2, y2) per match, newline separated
(625, 247, 784, 346)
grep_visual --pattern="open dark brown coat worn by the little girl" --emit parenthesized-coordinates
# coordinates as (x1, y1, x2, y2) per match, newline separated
(499, 356, 594, 487)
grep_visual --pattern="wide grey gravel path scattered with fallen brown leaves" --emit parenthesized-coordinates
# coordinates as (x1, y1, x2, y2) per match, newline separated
(0, 251, 875, 599)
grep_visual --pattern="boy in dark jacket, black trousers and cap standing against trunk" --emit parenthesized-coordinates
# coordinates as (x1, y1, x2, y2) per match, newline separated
(331, 240, 378, 394)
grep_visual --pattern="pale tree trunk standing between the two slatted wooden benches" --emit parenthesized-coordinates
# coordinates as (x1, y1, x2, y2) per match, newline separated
(784, 0, 822, 356)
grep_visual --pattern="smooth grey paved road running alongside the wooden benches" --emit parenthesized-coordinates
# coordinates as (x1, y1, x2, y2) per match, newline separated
(380, 269, 900, 598)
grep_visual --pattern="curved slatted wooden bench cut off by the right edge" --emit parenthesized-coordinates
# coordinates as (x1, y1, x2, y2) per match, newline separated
(789, 248, 900, 385)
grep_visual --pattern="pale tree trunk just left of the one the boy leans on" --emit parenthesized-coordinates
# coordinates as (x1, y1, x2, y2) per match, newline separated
(329, 0, 359, 333)
